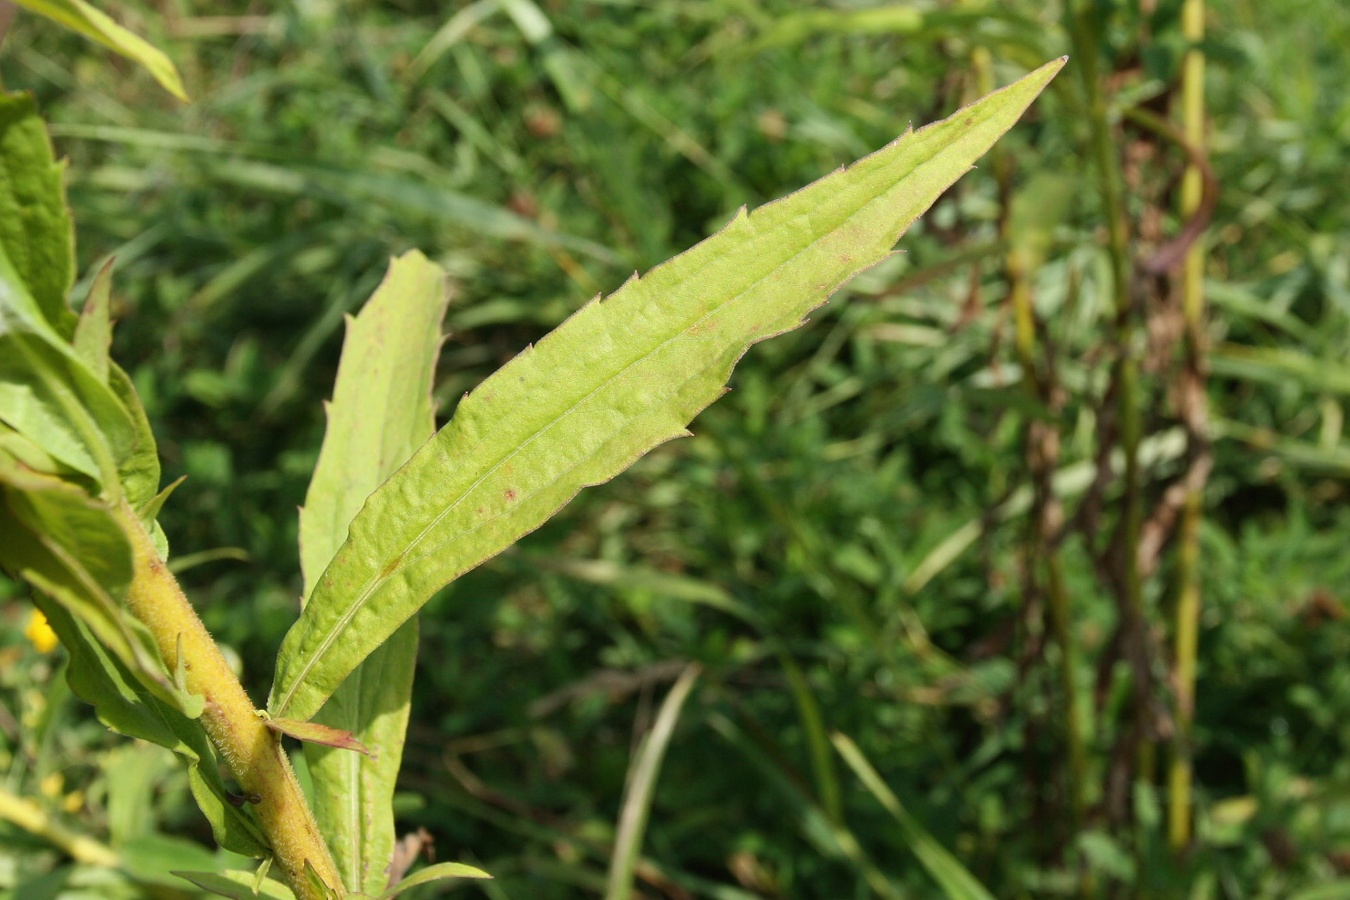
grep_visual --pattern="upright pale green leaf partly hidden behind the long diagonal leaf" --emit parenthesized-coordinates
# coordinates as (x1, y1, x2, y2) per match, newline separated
(295, 252, 448, 896)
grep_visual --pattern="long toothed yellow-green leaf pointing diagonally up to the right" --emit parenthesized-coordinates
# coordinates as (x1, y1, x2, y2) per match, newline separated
(271, 59, 1065, 719)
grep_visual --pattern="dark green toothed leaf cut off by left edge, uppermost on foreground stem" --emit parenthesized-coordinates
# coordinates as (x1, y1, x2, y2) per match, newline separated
(0, 93, 76, 339)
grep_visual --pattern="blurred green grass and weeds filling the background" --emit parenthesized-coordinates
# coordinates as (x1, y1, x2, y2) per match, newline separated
(0, 0, 1350, 900)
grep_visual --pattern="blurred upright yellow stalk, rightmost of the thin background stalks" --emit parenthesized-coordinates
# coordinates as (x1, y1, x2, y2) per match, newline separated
(1168, 0, 1208, 853)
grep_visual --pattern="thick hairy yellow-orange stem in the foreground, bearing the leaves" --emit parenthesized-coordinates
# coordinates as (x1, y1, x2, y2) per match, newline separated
(119, 506, 342, 900)
